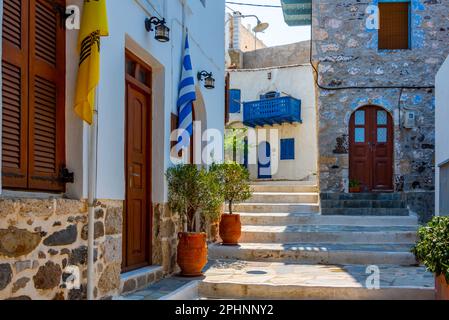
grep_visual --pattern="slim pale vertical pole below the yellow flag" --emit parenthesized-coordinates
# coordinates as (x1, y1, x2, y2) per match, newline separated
(87, 87, 98, 300)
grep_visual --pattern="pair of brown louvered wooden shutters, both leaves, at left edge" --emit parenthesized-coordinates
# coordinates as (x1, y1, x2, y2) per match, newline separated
(2, 0, 65, 191)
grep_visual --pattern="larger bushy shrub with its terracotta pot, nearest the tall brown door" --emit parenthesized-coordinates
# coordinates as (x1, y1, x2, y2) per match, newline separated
(166, 165, 224, 277)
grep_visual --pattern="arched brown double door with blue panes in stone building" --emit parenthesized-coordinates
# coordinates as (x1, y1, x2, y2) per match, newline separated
(349, 106, 394, 192)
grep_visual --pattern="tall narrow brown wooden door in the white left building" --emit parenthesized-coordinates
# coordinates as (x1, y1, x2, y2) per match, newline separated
(122, 52, 152, 271)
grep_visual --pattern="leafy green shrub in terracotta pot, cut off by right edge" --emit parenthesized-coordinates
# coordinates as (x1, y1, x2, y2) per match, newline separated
(412, 217, 449, 300)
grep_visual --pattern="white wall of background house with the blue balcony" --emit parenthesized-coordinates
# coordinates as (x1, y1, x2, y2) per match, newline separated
(229, 65, 318, 180)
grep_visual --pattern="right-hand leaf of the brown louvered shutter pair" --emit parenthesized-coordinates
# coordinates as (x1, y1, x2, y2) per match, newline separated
(28, 0, 65, 191)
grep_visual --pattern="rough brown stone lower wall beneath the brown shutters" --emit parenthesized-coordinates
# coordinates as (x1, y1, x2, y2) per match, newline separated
(0, 198, 123, 300)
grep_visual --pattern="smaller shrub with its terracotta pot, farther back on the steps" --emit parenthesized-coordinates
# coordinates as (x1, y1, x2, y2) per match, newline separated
(211, 162, 252, 245)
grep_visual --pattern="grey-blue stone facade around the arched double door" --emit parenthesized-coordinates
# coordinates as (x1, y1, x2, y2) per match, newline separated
(312, 0, 449, 221)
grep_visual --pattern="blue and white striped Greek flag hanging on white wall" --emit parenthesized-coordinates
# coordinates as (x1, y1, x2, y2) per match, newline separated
(176, 34, 196, 152)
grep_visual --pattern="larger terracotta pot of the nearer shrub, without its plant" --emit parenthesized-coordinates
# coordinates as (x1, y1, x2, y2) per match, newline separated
(177, 232, 207, 277)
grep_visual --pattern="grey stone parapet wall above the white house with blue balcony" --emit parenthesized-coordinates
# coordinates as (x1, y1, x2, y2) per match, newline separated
(243, 41, 310, 69)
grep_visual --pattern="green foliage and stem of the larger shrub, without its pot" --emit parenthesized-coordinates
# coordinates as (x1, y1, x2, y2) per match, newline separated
(166, 165, 224, 232)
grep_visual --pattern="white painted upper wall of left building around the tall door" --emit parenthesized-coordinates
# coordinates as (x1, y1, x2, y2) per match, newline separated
(0, 0, 225, 202)
